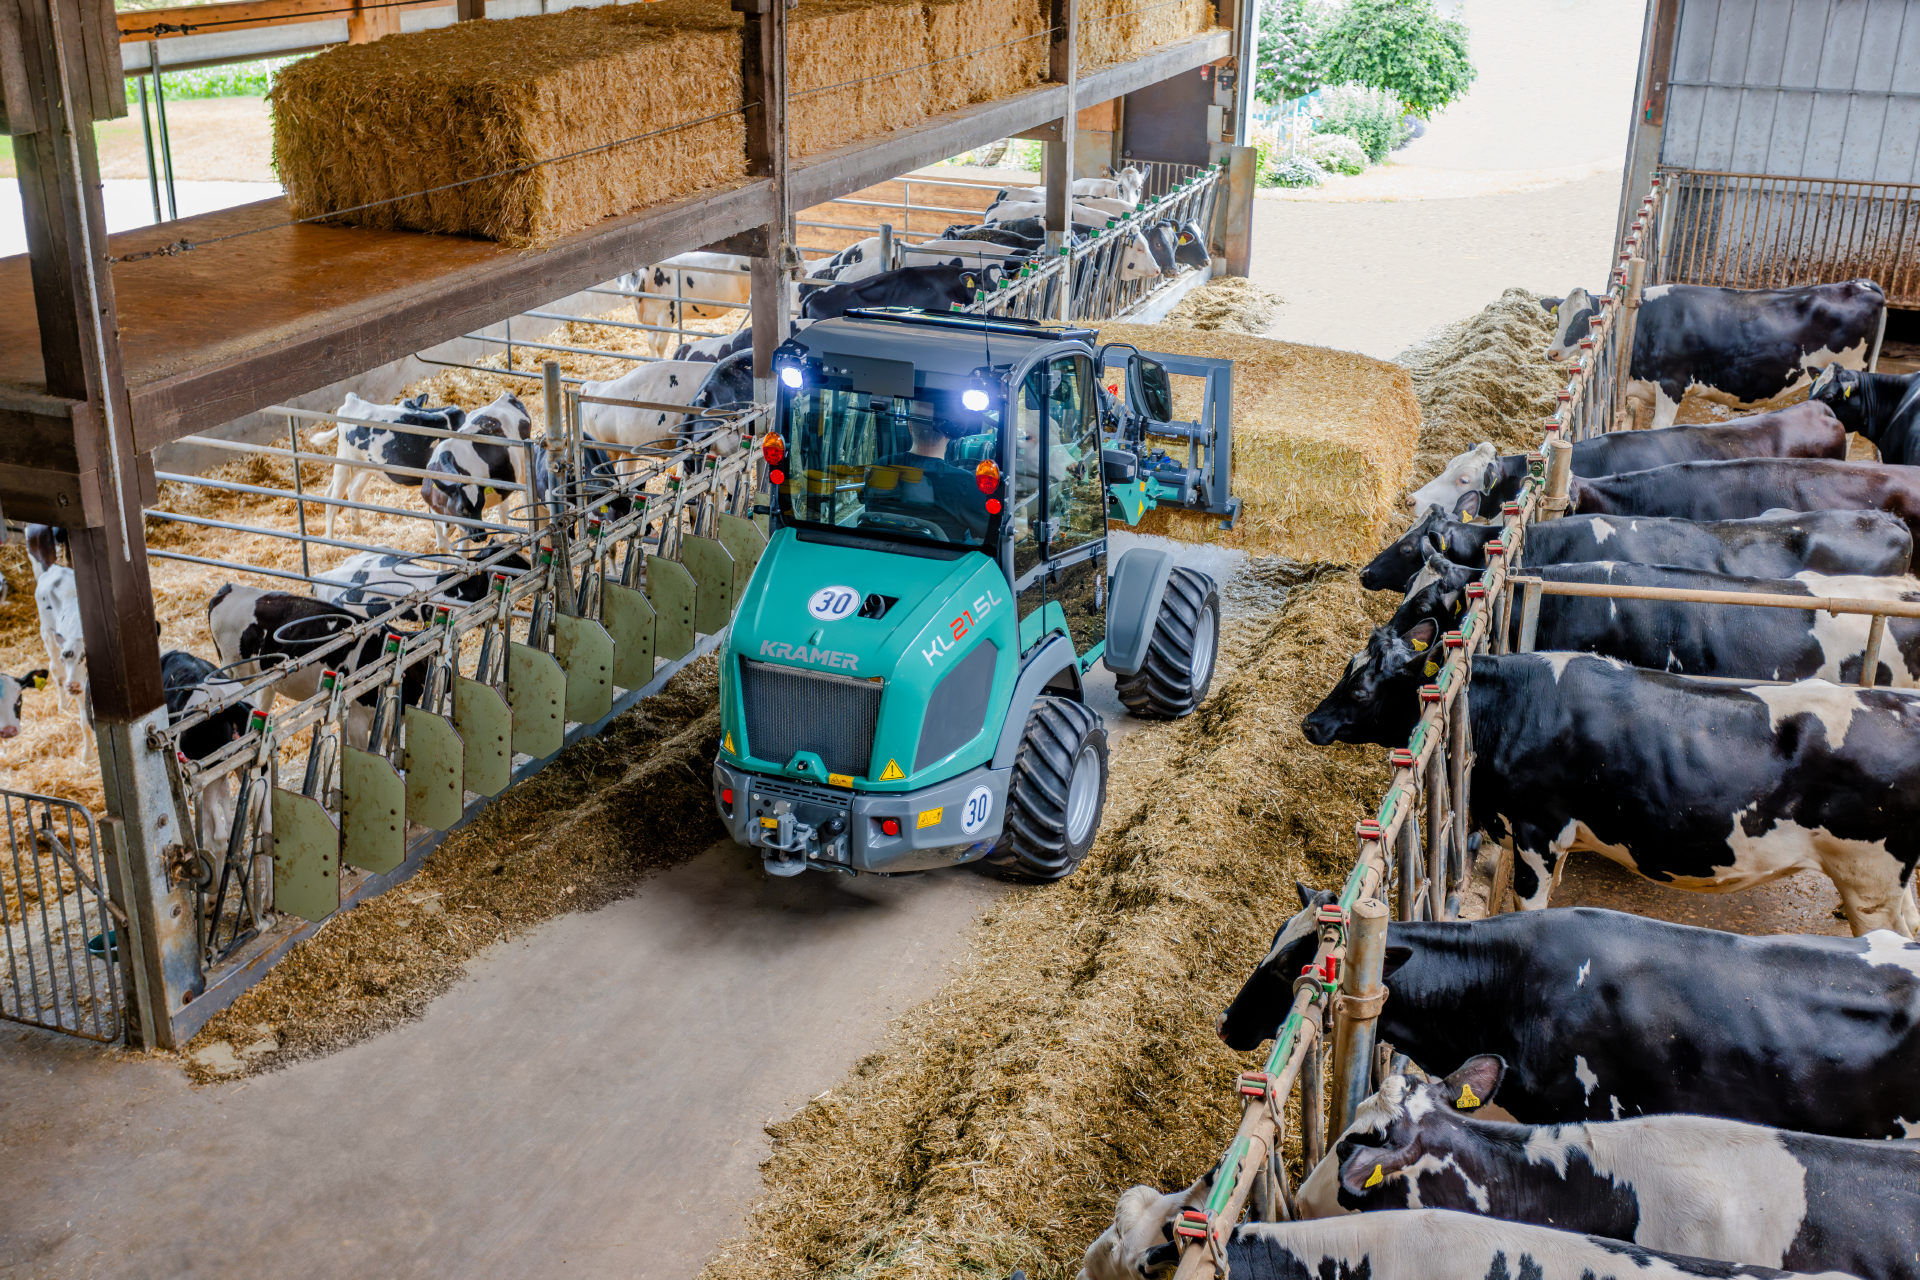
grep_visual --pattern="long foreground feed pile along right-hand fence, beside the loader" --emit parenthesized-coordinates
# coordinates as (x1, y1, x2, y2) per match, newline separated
(703, 558, 1394, 1280)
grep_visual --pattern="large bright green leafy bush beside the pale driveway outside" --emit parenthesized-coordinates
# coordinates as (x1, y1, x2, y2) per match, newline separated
(1319, 0, 1475, 117)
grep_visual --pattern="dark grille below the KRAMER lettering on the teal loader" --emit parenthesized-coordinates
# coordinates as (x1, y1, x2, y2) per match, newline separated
(739, 658, 881, 777)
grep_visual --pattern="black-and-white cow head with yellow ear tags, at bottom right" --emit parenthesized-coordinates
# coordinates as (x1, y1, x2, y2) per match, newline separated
(1298, 1054, 1507, 1219)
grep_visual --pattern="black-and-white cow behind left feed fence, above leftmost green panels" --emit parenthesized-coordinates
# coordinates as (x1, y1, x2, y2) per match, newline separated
(207, 581, 426, 747)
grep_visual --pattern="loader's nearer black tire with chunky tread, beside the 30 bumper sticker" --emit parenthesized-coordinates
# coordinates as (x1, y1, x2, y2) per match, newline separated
(987, 697, 1106, 883)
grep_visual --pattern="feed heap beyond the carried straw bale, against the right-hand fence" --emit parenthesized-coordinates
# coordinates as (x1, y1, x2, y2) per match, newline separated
(1394, 290, 1567, 487)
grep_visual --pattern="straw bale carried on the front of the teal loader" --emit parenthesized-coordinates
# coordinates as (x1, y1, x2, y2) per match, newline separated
(1100, 324, 1421, 564)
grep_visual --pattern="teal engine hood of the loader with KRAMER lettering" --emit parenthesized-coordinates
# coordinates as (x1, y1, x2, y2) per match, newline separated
(720, 528, 1020, 793)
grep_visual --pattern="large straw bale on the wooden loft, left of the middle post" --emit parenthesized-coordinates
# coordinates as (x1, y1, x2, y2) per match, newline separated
(271, 0, 747, 246)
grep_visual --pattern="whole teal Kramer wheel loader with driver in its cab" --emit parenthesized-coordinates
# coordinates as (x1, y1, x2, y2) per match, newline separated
(712, 309, 1238, 881)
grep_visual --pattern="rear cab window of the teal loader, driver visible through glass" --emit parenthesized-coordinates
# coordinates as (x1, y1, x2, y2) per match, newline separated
(781, 386, 1000, 547)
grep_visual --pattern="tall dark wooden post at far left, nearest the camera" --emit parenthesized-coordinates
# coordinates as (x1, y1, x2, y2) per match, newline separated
(8, 0, 187, 1048)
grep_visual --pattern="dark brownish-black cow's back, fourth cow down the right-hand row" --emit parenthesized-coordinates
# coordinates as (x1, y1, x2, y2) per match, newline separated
(1567, 459, 1920, 537)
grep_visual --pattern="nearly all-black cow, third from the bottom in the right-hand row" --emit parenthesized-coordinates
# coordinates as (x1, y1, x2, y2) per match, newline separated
(1219, 898, 1920, 1138)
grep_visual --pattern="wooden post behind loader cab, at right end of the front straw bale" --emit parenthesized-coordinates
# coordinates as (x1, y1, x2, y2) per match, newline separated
(733, 0, 801, 403)
